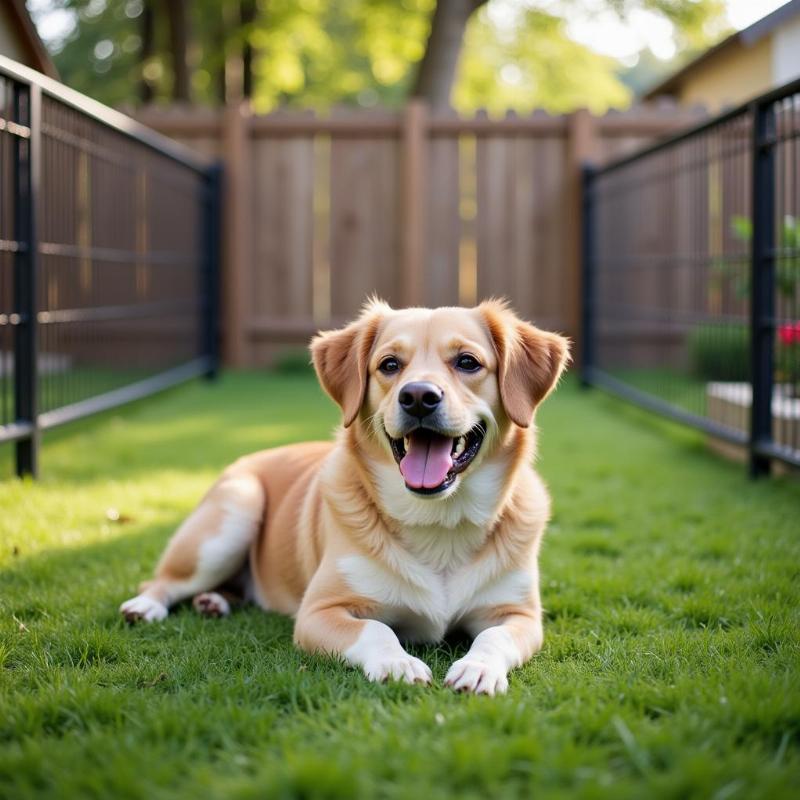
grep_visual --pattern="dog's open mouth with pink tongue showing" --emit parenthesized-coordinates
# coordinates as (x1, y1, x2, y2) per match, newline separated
(386, 422, 486, 494)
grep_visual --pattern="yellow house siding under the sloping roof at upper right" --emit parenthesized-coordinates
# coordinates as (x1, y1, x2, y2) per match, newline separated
(677, 36, 773, 111)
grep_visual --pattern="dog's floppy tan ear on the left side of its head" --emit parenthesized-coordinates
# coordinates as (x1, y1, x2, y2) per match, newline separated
(311, 302, 384, 428)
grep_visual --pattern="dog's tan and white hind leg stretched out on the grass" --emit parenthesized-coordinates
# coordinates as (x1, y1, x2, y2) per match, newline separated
(120, 467, 265, 622)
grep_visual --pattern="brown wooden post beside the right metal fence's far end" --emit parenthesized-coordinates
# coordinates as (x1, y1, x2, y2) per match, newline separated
(564, 108, 597, 356)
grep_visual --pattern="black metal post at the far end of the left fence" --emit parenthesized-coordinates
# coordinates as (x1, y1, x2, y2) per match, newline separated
(201, 161, 222, 380)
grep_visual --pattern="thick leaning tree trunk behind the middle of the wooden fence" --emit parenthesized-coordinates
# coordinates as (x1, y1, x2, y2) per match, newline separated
(411, 0, 487, 110)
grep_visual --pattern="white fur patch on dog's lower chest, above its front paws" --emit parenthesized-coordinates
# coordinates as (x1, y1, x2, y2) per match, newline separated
(338, 555, 532, 641)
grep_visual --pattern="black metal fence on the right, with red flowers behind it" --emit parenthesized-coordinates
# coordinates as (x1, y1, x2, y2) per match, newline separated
(583, 76, 800, 475)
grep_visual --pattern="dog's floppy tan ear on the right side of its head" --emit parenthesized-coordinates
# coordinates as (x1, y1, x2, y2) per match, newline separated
(478, 300, 569, 428)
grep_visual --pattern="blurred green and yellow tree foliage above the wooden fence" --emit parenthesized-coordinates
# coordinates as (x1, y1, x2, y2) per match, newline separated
(28, 0, 727, 112)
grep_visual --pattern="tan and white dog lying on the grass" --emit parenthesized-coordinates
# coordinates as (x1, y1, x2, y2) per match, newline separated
(121, 301, 567, 694)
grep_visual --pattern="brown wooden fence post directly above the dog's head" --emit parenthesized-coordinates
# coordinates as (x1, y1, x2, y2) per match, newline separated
(402, 99, 428, 306)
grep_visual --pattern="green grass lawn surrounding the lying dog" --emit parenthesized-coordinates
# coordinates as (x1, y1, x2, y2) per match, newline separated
(0, 374, 800, 800)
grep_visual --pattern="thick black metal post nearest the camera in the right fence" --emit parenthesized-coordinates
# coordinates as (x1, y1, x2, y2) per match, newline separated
(750, 102, 775, 478)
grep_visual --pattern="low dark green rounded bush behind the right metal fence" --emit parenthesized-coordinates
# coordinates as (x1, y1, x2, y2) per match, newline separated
(687, 323, 750, 381)
